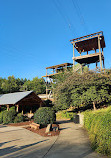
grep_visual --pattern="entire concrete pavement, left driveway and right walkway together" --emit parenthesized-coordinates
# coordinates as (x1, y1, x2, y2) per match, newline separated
(0, 121, 106, 158)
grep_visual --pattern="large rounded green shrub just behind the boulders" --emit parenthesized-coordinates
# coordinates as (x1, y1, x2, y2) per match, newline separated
(34, 107, 56, 125)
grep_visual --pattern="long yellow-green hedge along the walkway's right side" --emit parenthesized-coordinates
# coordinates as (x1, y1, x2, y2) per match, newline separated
(84, 107, 111, 155)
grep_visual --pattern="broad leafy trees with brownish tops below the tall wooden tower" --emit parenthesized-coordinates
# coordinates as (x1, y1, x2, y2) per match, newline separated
(54, 71, 111, 110)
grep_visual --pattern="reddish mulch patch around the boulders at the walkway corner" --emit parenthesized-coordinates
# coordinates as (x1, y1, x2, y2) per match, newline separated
(24, 124, 60, 137)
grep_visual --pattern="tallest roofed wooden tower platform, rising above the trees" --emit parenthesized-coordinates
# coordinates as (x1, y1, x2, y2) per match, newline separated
(70, 31, 105, 71)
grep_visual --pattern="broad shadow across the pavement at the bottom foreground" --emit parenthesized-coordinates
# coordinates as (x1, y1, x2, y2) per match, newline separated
(11, 142, 96, 158)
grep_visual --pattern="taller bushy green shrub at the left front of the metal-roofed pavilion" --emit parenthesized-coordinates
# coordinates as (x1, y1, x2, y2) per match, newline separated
(3, 107, 16, 124)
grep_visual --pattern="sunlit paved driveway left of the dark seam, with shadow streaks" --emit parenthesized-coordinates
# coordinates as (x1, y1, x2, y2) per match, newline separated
(0, 126, 57, 158)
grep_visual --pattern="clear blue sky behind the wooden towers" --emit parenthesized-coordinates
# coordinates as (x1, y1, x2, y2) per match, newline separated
(0, 0, 111, 79)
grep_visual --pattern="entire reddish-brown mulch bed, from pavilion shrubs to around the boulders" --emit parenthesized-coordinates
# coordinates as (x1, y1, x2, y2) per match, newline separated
(8, 120, 60, 137)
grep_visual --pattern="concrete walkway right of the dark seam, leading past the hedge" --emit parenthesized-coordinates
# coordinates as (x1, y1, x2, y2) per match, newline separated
(45, 121, 105, 158)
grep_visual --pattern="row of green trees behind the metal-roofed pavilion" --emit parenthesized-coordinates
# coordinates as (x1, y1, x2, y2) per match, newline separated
(0, 76, 45, 94)
